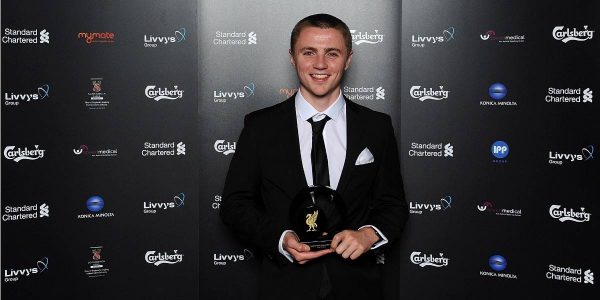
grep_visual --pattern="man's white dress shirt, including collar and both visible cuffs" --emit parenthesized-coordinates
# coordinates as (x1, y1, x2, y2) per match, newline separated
(279, 90, 388, 262)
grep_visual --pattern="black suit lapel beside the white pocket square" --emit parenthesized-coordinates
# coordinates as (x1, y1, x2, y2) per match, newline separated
(337, 99, 363, 193)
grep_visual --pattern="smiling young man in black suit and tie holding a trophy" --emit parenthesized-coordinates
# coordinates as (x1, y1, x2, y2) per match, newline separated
(221, 14, 407, 300)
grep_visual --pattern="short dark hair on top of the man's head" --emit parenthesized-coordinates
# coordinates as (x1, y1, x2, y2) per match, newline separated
(290, 14, 352, 54)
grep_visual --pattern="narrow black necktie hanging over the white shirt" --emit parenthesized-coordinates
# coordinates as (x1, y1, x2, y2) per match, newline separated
(308, 115, 331, 186)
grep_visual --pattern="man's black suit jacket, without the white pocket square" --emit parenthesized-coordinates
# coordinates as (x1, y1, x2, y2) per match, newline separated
(220, 96, 408, 300)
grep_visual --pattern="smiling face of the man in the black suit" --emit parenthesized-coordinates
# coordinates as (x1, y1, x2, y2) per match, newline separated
(290, 27, 352, 102)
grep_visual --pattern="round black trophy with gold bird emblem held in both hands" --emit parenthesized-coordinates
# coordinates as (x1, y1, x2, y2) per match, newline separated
(290, 186, 346, 251)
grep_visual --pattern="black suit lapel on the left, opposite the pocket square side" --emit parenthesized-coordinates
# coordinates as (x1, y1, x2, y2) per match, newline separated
(279, 95, 307, 197)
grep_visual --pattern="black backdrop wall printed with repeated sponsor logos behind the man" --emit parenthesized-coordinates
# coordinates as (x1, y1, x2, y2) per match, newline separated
(1, 0, 600, 299)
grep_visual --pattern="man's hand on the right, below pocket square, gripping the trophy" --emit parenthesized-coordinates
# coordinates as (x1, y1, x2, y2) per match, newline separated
(331, 227, 379, 260)
